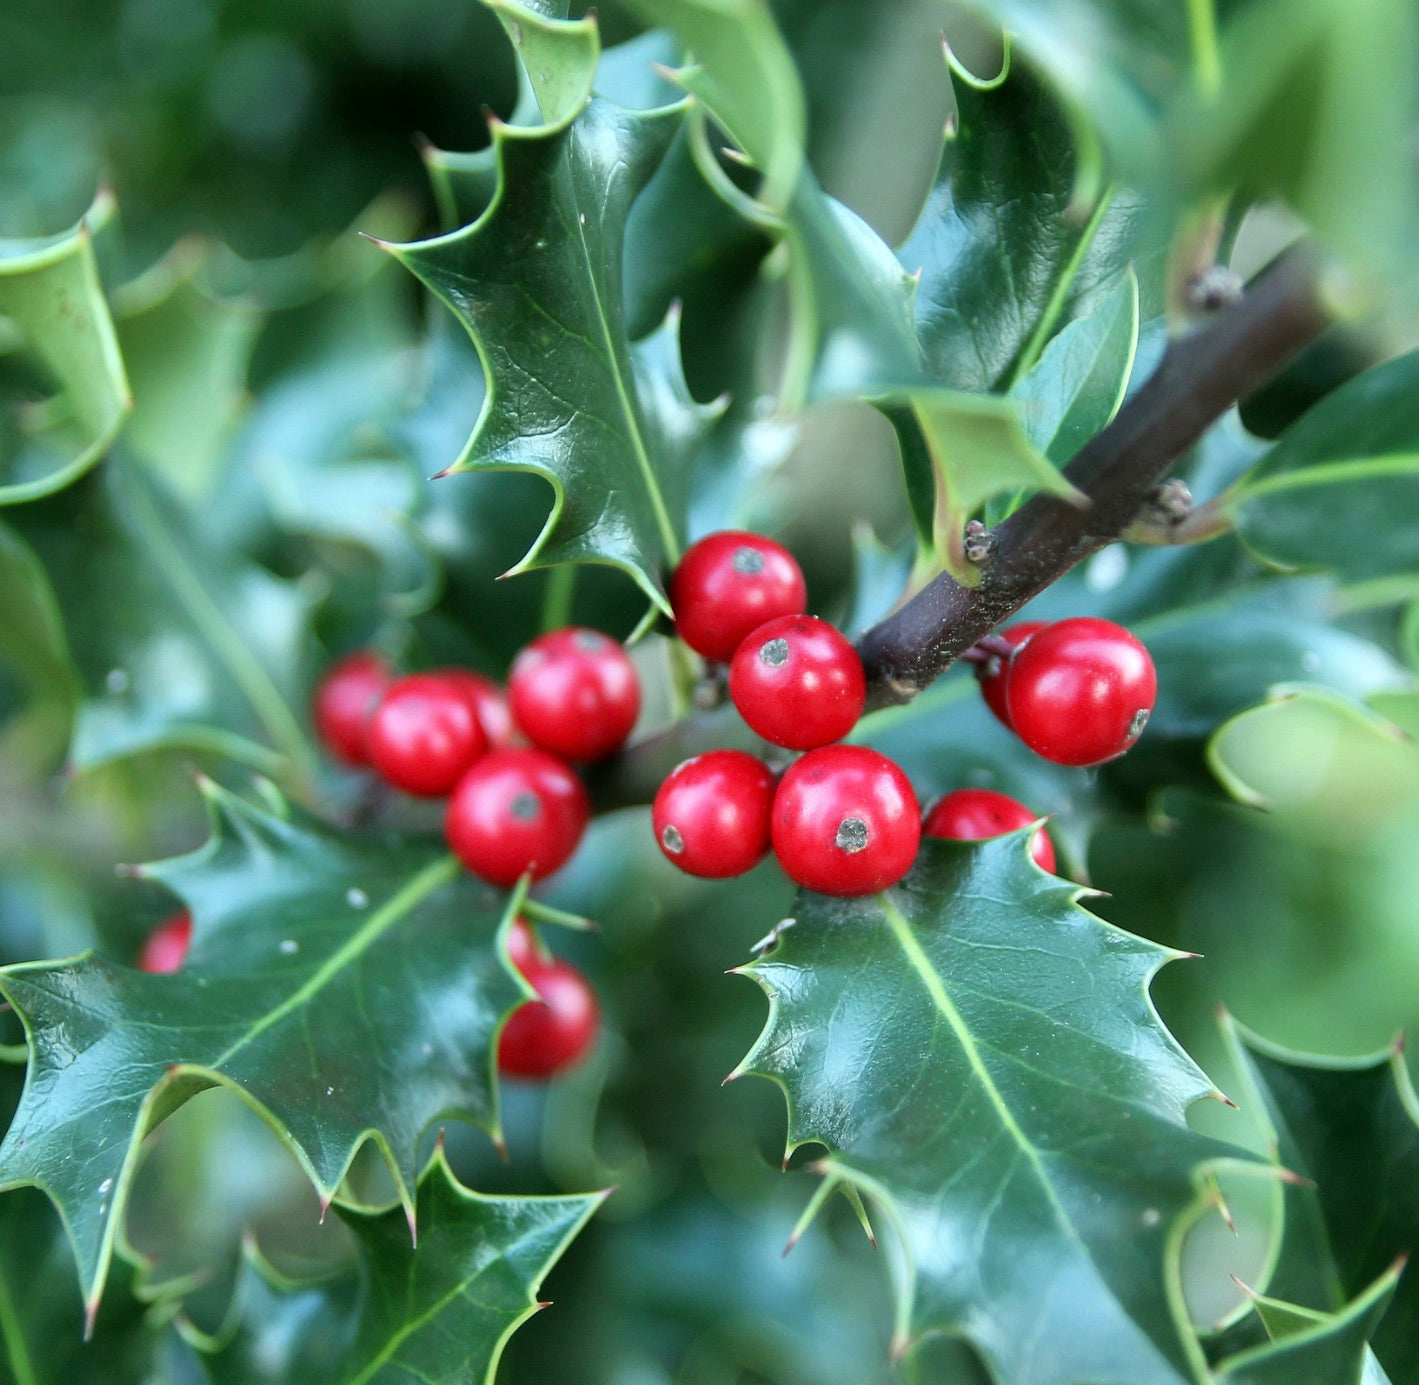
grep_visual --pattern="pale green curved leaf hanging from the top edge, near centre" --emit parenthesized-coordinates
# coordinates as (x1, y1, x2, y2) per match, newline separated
(629, 0, 807, 211)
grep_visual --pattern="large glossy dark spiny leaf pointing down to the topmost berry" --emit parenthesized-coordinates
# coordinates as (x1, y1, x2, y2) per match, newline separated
(390, 99, 712, 609)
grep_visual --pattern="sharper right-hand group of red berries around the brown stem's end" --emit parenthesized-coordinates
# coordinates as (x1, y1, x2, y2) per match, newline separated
(651, 531, 1156, 895)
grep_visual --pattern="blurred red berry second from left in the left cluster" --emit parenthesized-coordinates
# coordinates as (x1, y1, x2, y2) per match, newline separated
(365, 673, 488, 799)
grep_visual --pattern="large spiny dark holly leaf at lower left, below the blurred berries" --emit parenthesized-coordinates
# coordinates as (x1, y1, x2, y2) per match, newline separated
(0, 782, 522, 1314)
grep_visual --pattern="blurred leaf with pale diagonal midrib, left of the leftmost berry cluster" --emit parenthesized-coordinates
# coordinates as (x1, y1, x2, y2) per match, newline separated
(0, 456, 314, 779)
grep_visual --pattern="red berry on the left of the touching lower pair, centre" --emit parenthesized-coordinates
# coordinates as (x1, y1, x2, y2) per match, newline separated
(651, 751, 773, 880)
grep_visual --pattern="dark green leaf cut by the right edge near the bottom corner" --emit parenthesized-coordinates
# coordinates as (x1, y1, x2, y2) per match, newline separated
(1229, 1023, 1419, 1381)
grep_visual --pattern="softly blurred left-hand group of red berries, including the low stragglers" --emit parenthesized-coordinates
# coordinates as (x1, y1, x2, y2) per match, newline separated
(139, 629, 640, 1077)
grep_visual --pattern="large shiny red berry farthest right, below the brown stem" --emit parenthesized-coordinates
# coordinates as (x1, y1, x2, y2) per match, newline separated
(1006, 616, 1158, 765)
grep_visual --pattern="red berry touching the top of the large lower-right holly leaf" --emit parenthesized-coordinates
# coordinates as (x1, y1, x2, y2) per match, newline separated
(773, 745, 921, 894)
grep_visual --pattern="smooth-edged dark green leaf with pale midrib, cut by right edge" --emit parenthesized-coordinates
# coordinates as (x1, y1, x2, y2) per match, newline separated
(1225, 352, 1419, 582)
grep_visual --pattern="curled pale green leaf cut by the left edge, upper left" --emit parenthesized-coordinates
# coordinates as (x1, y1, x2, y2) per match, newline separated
(0, 194, 132, 505)
